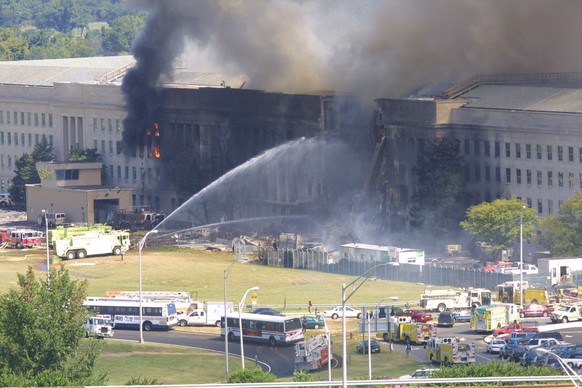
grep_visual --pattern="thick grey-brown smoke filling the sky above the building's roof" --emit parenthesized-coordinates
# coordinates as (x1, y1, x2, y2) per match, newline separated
(125, 0, 582, 99)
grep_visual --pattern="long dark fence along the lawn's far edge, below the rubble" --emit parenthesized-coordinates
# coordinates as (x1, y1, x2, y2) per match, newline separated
(259, 248, 552, 290)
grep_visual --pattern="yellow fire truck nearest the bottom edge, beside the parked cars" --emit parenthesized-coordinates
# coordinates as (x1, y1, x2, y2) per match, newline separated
(426, 337, 475, 366)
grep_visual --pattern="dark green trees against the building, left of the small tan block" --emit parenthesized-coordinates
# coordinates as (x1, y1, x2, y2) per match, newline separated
(9, 135, 54, 204)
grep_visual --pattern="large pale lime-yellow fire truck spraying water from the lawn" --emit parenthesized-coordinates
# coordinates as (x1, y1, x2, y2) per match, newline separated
(53, 230, 130, 260)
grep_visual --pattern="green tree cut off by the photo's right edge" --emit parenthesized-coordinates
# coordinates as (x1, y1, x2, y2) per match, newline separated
(537, 193, 582, 256)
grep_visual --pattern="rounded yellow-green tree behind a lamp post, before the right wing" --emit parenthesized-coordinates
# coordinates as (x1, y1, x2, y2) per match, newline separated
(461, 197, 539, 254)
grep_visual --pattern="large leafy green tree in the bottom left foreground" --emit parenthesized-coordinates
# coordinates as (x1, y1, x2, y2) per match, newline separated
(0, 267, 107, 386)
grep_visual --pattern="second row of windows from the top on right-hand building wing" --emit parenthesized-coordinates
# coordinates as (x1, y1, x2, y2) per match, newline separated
(465, 164, 582, 189)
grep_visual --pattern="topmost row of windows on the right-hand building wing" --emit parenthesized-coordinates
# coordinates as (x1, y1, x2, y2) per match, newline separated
(463, 140, 582, 163)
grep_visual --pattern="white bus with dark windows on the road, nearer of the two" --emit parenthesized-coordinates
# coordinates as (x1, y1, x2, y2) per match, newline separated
(220, 313, 303, 346)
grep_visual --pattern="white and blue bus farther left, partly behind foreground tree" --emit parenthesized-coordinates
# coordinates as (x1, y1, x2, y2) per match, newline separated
(83, 298, 178, 331)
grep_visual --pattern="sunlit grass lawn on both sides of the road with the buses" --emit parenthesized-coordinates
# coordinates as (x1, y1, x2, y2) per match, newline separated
(0, 247, 434, 385)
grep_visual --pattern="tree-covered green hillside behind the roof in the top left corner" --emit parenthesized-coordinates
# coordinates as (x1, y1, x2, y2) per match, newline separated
(0, 0, 145, 61)
